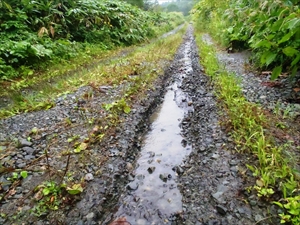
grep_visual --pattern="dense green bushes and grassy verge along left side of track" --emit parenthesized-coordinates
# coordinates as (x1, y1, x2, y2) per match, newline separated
(0, 0, 184, 118)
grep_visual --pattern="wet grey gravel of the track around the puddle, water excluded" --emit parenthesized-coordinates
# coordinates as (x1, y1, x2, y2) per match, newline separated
(0, 27, 300, 225)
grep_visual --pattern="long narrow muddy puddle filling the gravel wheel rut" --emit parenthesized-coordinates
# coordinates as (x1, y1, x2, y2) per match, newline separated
(115, 36, 193, 225)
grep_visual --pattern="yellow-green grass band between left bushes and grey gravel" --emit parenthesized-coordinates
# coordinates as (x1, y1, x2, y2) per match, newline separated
(0, 22, 186, 119)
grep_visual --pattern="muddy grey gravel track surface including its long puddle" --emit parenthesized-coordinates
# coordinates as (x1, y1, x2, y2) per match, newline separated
(0, 26, 286, 225)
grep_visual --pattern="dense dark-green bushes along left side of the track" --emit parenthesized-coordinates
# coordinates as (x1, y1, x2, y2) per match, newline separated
(0, 0, 183, 80)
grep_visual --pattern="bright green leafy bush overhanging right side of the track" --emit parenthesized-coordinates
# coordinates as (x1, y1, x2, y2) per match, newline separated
(193, 0, 300, 79)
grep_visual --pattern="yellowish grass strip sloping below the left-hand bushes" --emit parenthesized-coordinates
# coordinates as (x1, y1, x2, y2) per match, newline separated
(0, 24, 184, 119)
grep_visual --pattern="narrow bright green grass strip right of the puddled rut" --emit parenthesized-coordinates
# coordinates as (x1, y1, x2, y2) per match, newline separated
(196, 23, 300, 224)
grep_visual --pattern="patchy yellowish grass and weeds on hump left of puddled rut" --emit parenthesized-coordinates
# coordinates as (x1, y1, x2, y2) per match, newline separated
(0, 26, 186, 222)
